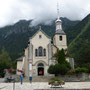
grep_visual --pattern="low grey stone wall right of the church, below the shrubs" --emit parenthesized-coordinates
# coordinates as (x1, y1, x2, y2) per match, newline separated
(58, 73, 89, 82)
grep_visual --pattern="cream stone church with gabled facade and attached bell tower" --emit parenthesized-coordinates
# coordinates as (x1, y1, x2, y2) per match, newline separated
(17, 11, 74, 77)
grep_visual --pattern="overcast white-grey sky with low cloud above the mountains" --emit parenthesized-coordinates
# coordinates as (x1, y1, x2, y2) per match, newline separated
(0, 0, 90, 27)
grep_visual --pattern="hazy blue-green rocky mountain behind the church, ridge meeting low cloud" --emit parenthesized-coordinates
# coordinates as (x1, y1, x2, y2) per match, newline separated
(0, 18, 79, 59)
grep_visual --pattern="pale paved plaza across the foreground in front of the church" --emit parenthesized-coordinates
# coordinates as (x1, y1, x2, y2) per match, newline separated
(0, 82, 90, 90)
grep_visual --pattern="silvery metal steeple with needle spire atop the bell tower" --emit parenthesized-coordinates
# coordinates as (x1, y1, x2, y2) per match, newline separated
(56, 3, 64, 33)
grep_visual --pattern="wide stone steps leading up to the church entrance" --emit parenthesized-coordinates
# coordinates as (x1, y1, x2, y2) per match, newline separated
(23, 76, 53, 82)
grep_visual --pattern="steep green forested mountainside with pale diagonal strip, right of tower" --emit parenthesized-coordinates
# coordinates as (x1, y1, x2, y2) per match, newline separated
(68, 14, 90, 63)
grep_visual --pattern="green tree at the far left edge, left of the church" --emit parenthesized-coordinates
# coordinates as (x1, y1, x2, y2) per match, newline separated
(0, 48, 12, 77)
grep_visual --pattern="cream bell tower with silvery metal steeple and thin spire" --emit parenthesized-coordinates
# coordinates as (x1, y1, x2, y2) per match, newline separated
(53, 4, 67, 50)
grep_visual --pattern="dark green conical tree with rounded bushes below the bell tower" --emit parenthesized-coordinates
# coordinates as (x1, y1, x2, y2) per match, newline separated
(48, 49, 71, 75)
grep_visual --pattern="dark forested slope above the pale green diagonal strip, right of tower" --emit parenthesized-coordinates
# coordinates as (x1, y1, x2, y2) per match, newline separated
(66, 14, 90, 43)
